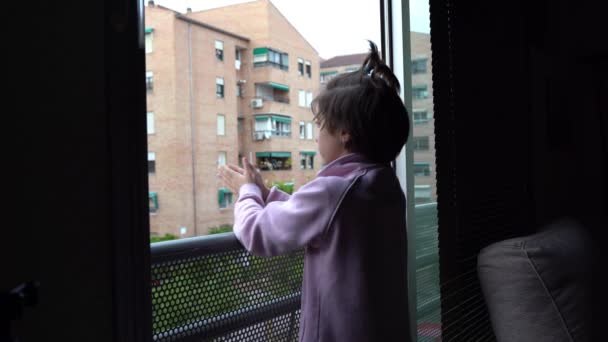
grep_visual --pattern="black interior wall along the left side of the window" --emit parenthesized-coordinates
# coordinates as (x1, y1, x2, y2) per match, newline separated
(5, 1, 113, 342)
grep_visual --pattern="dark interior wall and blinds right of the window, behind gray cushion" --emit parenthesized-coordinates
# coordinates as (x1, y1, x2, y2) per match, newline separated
(430, 0, 608, 340)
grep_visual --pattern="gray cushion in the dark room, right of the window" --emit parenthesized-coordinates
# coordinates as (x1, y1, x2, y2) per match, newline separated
(477, 219, 591, 342)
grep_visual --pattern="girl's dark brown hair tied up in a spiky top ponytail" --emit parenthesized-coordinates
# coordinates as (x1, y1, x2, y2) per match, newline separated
(312, 41, 410, 163)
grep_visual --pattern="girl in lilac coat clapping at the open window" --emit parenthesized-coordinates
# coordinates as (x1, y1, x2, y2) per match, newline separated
(220, 42, 410, 342)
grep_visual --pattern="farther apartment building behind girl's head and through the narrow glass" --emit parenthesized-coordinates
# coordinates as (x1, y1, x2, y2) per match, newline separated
(320, 32, 437, 203)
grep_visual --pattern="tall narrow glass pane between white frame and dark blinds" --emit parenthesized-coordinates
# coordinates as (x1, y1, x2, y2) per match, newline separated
(409, 0, 441, 341)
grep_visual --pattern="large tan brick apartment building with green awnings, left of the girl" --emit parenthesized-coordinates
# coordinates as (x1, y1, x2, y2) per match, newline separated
(145, 0, 321, 237)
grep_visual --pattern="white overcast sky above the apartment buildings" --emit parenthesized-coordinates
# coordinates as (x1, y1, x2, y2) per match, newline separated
(152, 0, 429, 59)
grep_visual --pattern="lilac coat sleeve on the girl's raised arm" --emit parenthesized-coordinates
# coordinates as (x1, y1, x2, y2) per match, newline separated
(234, 177, 350, 256)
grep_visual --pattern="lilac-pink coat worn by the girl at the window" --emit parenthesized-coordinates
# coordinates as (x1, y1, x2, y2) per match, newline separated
(234, 154, 410, 342)
